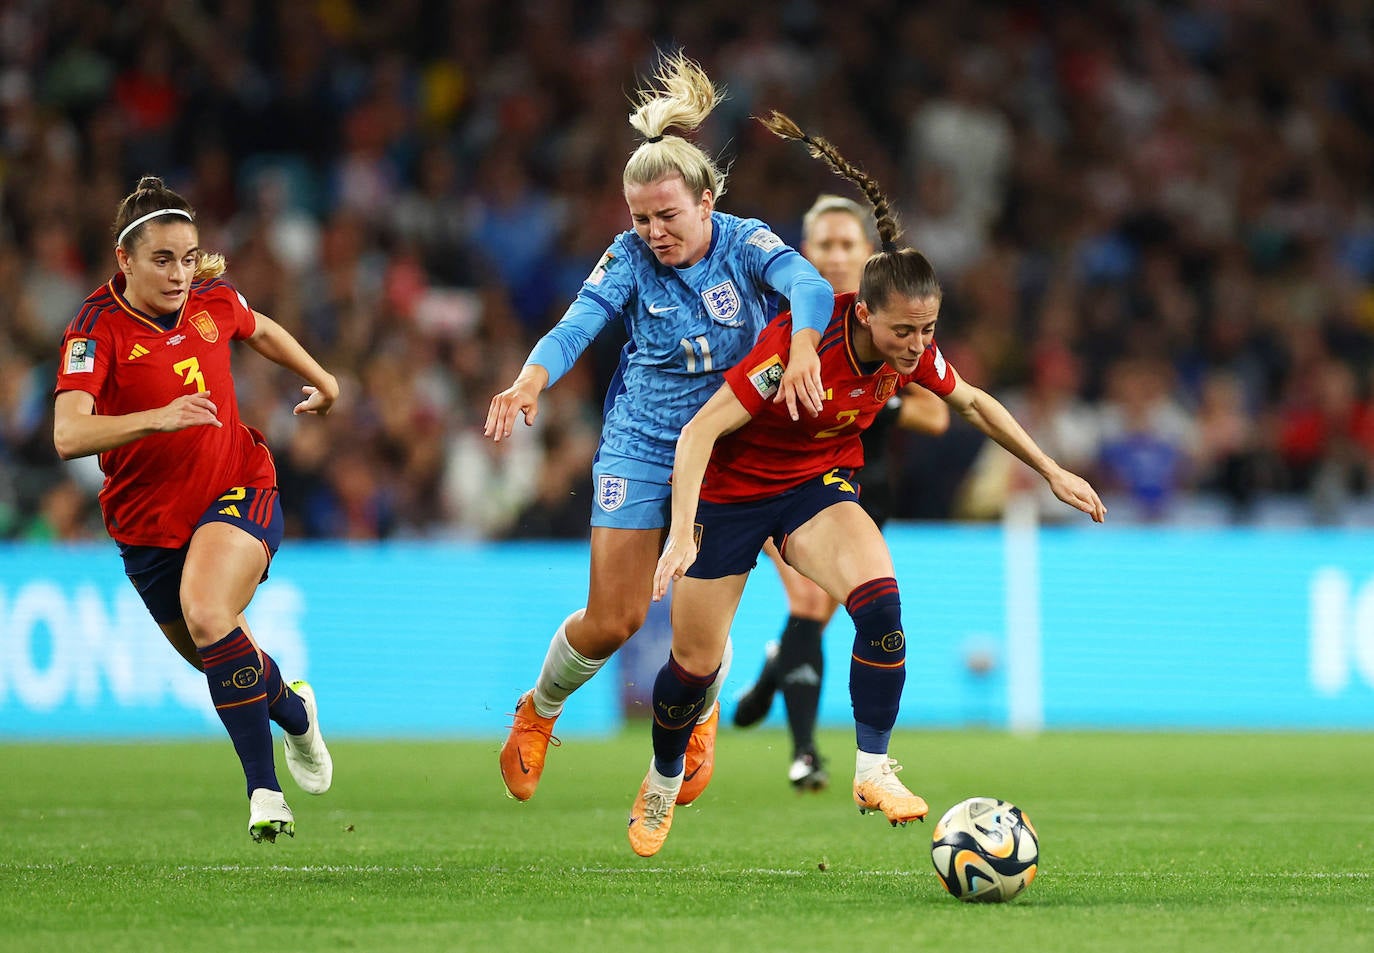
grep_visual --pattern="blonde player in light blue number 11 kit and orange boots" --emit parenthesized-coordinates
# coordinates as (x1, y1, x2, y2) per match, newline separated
(485, 52, 833, 803)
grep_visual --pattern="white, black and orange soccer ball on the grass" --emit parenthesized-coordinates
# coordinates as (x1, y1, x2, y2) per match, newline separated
(930, 798, 1040, 904)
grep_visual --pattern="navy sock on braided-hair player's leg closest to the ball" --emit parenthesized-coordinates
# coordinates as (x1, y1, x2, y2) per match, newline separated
(845, 577, 907, 754)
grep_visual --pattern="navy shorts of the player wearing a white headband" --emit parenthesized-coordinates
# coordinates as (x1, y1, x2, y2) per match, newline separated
(120, 486, 284, 625)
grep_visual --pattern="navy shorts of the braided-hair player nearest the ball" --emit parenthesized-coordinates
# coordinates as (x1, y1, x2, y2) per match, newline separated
(687, 470, 859, 579)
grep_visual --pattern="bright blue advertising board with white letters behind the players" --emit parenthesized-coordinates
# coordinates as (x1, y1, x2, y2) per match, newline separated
(0, 525, 1374, 739)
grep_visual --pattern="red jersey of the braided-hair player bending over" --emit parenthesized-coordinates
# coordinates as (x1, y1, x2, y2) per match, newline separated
(701, 292, 955, 503)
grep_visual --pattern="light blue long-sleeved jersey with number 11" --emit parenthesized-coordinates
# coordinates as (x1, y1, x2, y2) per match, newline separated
(528, 211, 834, 483)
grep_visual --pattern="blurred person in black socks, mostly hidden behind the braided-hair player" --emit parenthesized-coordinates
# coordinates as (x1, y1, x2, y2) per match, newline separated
(734, 195, 949, 791)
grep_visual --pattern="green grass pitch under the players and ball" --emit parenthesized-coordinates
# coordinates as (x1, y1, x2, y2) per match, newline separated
(0, 725, 1374, 953)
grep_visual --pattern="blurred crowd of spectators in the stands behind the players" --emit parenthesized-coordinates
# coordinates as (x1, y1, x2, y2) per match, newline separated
(0, 0, 1374, 540)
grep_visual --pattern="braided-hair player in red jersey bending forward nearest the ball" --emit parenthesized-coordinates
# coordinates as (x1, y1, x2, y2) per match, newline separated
(629, 113, 1106, 857)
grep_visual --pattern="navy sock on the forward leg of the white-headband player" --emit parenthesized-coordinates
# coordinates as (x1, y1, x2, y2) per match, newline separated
(196, 629, 282, 795)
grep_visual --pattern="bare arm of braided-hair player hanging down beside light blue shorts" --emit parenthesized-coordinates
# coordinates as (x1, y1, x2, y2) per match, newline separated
(654, 384, 750, 603)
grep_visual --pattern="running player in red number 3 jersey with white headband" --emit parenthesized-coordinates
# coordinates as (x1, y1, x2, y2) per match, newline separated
(52, 176, 338, 842)
